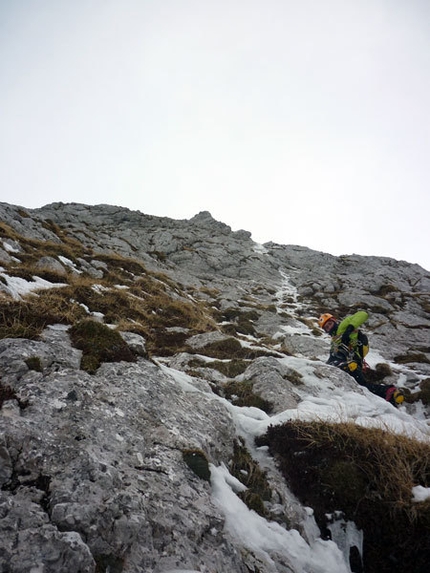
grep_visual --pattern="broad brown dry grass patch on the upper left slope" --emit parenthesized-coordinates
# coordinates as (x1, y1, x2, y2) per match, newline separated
(0, 220, 222, 354)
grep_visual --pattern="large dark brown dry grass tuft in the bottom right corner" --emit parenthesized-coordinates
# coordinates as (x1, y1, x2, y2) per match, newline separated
(257, 421, 430, 573)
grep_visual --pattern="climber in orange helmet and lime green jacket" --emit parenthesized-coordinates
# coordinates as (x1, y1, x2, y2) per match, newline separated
(318, 310, 405, 407)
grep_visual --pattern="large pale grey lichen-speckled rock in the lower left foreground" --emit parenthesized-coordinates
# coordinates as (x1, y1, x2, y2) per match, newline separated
(0, 333, 250, 572)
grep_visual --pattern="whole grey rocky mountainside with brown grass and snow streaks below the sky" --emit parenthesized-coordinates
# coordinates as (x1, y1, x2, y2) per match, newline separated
(0, 203, 430, 573)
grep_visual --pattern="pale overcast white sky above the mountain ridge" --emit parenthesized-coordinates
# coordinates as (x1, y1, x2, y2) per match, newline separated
(0, 0, 430, 270)
